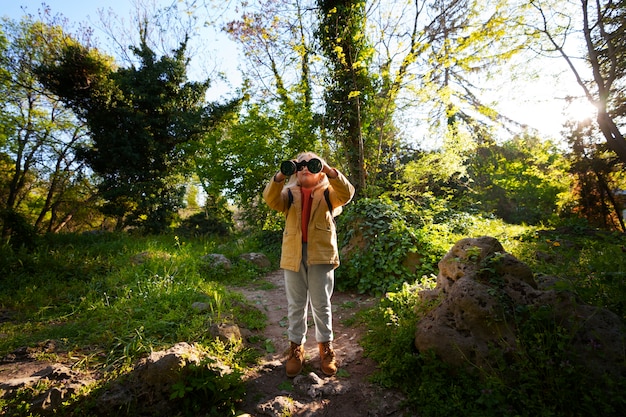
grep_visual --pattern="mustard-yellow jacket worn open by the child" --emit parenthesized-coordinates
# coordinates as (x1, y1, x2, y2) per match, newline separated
(263, 171, 354, 272)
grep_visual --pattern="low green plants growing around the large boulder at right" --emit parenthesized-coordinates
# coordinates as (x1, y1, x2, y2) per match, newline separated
(361, 219, 626, 417)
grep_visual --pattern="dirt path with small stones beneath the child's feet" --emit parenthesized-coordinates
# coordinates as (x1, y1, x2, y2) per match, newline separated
(234, 270, 404, 417)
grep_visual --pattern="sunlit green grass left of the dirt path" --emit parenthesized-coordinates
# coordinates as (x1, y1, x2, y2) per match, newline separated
(0, 234, 267, 415)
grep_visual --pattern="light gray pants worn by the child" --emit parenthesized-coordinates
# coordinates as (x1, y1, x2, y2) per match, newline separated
(285, 243, 335, 345)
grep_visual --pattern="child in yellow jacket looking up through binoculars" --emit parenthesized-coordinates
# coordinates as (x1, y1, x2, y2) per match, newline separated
(263, 152, 354, 377)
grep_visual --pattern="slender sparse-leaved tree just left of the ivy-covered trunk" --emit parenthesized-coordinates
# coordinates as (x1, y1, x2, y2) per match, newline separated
(225, 0, 322, 155)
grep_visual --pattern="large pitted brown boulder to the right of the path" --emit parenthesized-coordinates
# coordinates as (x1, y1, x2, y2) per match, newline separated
(415, 237, 625, 376)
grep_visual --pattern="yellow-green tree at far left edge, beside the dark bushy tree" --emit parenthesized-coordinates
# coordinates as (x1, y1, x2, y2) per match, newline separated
(0, 16, 93, 240)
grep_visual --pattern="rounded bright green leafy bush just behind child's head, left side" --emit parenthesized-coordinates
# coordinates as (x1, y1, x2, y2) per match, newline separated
(194, 103, 317, 227)
